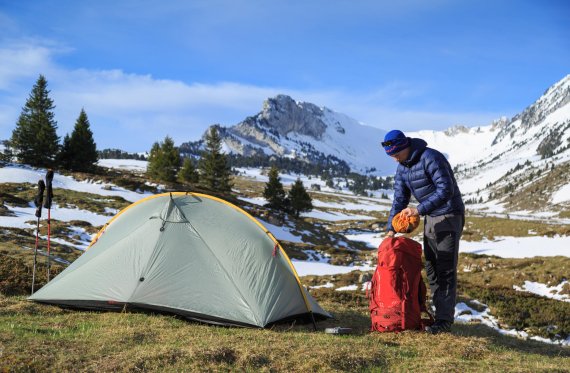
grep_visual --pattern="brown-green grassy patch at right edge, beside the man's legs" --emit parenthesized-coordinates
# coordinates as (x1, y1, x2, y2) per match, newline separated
(458, 254, 570, 339)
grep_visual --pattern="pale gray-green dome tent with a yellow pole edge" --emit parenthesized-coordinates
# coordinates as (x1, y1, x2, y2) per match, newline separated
(29, 192, 330, 327)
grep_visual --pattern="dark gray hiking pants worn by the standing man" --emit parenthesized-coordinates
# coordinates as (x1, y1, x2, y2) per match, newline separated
(424, 214, 465, 322)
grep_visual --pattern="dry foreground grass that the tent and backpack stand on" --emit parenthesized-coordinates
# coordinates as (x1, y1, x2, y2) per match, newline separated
(0, 292, 570, 372)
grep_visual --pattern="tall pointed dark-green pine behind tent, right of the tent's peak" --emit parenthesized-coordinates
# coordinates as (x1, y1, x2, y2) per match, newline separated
(199, 126, 233, 194)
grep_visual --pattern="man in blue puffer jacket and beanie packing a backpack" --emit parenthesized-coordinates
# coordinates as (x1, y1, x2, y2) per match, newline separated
(382, 130, 465, 334)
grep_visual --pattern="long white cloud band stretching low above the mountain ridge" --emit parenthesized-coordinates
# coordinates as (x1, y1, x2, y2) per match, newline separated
(0, 40, 499, 151)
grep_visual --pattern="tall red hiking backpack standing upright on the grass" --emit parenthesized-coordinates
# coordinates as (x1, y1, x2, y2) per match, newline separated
(367, 237, 433, 332)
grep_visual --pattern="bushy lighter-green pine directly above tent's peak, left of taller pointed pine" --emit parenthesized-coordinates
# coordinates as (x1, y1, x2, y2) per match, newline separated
(146, 136, 180, 182)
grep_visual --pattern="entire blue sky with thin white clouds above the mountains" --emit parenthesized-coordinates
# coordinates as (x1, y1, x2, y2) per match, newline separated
(0, 0, 570, 151)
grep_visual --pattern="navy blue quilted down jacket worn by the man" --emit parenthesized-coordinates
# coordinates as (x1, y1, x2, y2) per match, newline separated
(387, 138, 465, 231)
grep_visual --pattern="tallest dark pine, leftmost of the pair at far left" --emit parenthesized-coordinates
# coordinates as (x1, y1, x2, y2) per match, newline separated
(10, 75, 59, 167)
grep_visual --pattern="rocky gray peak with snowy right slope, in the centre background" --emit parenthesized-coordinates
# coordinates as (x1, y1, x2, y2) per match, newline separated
(181, 95, 395, 174)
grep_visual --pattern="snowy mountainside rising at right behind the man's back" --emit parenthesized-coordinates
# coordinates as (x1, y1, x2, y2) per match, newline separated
(409, 75, 570, 212)
